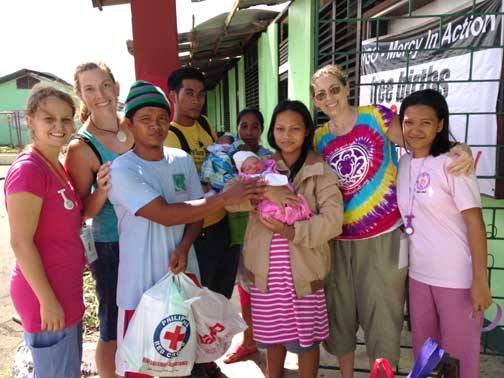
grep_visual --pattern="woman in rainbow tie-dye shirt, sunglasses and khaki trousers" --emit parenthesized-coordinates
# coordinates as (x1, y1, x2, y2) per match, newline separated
(311, 65, 472, 378)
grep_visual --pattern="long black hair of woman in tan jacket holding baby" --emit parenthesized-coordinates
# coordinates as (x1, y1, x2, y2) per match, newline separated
(268, 100, 315, 181)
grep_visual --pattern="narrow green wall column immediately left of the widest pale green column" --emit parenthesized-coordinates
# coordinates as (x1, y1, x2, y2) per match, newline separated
(257, 23, 280, 146)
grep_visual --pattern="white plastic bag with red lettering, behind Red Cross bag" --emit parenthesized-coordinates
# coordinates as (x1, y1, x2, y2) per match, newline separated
(178, 274, 247, 363)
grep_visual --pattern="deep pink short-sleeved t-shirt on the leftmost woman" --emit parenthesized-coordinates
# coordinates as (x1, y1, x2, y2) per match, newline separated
(4, 152, 85, 333)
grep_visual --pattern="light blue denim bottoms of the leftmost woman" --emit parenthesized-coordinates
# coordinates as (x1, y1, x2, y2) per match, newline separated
(24, 322, 82, 378)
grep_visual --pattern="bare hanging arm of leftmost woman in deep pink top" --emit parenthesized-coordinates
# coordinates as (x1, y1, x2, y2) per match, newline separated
(7, 192, 65, 332)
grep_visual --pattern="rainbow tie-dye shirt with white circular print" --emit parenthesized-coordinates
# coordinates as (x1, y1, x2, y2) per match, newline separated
(314, 105, 401, 239)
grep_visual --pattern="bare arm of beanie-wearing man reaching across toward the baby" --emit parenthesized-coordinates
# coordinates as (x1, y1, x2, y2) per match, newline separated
(135, 179, 264, 227)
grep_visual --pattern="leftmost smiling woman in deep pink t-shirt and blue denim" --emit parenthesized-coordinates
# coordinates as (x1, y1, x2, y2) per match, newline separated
(4, 87, 85, 378)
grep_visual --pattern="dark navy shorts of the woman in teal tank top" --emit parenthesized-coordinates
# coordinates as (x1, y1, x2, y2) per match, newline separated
(93, 242, 119, 341)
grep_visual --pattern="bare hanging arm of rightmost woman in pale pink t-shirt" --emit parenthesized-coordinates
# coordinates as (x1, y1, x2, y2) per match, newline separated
(462, 207, 492, 316)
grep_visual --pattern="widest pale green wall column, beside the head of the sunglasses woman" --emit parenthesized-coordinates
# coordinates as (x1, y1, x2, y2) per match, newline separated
(288, 0, 316, 109)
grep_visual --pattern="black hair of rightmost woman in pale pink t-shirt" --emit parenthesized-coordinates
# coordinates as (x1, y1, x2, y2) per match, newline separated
(399, 89, 455, 157)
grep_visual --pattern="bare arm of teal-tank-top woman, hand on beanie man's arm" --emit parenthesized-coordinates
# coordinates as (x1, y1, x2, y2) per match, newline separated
(64, 139, 110, 220)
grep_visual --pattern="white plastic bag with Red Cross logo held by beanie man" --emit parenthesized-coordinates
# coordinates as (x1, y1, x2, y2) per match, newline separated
(119, 273, 197, 377)
